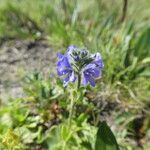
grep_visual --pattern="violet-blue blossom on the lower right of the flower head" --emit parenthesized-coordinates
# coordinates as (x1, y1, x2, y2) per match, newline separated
(82, 64, 101, 87)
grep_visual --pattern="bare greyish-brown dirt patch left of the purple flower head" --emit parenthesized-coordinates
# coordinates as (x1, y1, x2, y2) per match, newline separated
(0, 40, 56, 98)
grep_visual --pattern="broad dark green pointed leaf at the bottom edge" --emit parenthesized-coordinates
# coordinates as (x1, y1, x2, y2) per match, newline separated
(95, 121, 119, 150)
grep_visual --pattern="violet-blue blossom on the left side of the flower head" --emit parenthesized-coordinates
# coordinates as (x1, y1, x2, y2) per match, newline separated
(57, 53, 76, 86)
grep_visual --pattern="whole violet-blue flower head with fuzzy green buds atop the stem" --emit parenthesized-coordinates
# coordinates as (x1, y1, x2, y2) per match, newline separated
(57, 45, 104, 86)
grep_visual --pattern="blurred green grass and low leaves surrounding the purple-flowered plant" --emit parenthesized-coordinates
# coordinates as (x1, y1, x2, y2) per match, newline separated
(0, 0, 150, 150)
